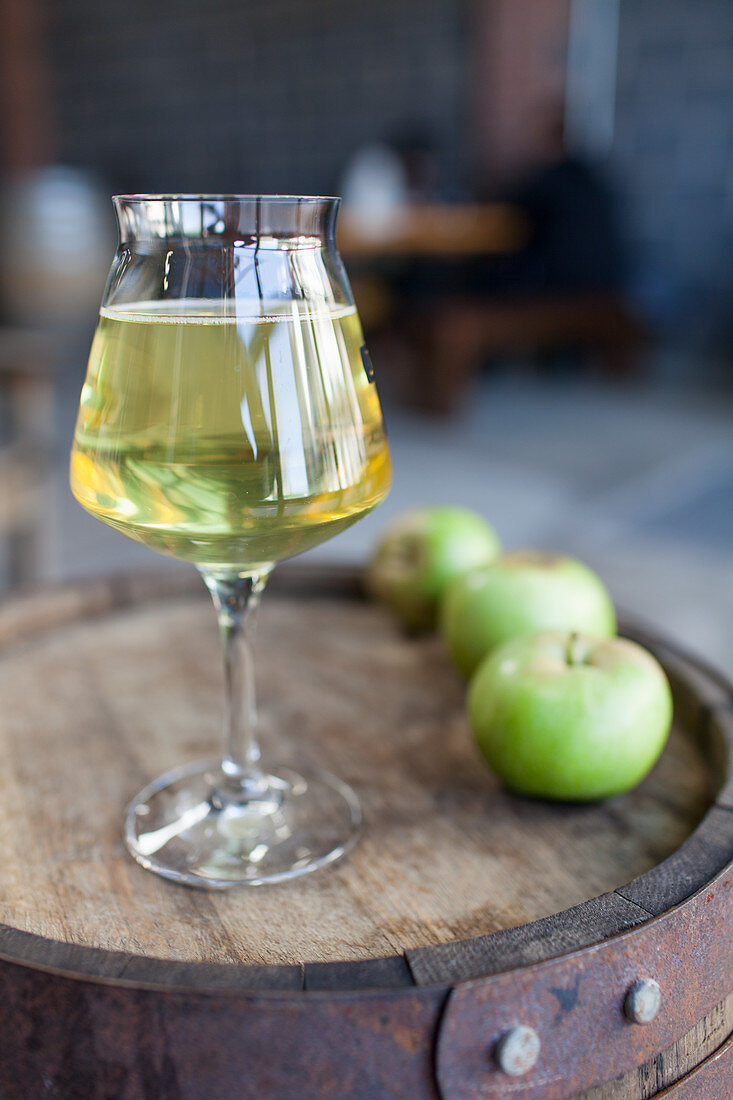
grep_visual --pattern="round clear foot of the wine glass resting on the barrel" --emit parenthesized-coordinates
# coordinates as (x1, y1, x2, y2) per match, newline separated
(124, 761, 361, 890)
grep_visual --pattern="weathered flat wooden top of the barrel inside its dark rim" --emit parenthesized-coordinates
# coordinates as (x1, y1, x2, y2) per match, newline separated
(0, 571, 714, 981)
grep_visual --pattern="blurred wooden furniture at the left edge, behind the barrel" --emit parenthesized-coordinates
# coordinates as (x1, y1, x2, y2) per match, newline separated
(0, 328, 53, 585)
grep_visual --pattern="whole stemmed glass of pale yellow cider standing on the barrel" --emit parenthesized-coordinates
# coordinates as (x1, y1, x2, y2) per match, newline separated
(70, 195, 391, 888)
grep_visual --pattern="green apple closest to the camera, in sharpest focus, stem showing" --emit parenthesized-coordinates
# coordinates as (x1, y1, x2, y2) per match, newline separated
(468, 631, 672, 802)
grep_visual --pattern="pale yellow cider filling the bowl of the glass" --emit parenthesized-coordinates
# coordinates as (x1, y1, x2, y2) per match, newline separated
(70, 299, 391, 570)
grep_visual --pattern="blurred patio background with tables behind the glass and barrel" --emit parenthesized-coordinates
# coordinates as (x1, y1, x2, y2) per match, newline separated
(0, 0, 733, 671)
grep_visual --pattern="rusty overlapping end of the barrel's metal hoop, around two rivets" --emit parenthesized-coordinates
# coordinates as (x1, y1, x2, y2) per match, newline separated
(436, 864, 733, 1100)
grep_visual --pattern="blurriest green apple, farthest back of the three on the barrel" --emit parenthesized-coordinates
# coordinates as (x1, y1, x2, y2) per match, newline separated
(364, 506, 501, 630)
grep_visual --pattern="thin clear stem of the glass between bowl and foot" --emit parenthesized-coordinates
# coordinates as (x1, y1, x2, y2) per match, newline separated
(201, 565, 272, 799)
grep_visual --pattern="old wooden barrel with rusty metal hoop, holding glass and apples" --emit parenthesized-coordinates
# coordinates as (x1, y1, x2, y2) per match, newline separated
(0, 567, 733, 1100)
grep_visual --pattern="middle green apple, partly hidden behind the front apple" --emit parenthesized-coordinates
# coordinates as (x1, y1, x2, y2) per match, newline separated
(440, 550, 616, 677)
